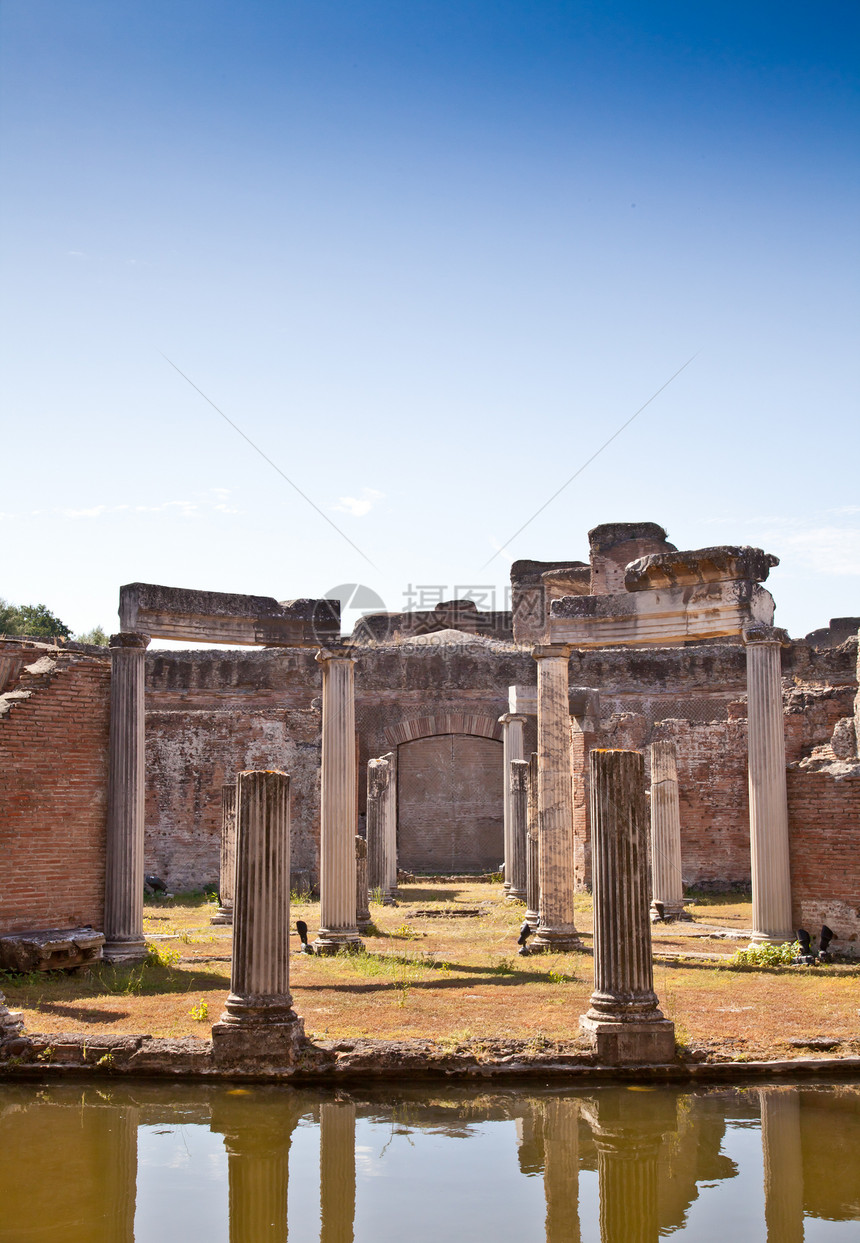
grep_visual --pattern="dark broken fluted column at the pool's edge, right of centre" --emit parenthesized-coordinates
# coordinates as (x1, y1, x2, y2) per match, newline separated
(579, 751, 675, 1064)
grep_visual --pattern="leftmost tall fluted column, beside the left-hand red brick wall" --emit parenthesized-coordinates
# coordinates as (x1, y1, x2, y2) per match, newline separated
(102, 634, 149, 962)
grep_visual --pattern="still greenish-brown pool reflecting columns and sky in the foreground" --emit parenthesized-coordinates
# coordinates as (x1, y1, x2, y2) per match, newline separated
(0, 1084, 860, 1243)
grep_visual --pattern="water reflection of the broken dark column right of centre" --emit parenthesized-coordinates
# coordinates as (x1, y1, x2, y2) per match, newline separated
(582, 1089, 677, 1243)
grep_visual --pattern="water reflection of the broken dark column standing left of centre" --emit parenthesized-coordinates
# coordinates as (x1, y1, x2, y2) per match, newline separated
(211, 1096, 301, 1243)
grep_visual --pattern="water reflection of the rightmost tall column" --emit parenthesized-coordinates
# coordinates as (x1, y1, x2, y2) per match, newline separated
(758, 1088, 803, 1243)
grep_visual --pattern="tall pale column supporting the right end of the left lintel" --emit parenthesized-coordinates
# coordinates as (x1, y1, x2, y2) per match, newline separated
(313, 648, 363, 953)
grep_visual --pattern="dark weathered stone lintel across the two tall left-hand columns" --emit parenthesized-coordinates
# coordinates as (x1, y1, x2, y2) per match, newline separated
(119, 583, 341, 648)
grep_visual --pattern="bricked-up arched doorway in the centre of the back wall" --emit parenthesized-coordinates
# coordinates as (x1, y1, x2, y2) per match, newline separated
(398, 733, 505, 874)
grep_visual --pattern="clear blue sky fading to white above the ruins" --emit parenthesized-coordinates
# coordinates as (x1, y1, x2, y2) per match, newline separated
(0, 0, 860, 635)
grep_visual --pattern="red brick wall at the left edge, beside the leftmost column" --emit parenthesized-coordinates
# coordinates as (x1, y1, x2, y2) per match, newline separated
(0, 643, 111, 932)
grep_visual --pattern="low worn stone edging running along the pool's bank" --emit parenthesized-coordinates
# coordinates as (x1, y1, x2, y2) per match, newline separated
(0, 1033, 860, 1086)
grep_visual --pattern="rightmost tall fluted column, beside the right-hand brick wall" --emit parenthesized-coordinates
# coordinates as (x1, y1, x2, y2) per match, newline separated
(743, 625, 794, 945)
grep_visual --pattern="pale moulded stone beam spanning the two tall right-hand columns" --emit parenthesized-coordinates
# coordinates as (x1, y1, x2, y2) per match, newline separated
(546, 579, 774, 651)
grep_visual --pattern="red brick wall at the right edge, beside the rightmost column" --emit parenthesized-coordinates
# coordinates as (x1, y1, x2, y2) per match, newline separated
(788, 768, 860, 955)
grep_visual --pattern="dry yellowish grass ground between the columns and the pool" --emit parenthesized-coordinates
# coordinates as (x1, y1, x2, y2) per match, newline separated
(0, 884, 860, 1058)
